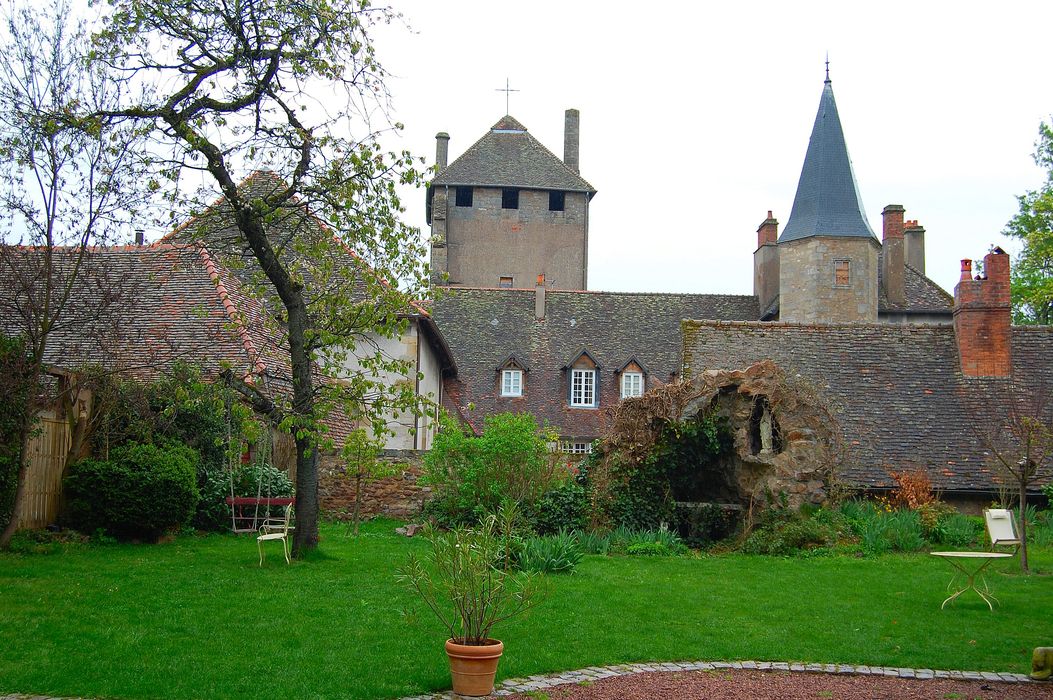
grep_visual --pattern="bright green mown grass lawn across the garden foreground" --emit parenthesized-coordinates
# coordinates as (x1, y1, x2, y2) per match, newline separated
(0, 521, 1053, 698)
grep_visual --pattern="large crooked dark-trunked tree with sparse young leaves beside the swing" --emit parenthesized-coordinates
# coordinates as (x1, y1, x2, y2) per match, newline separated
(96, 0, 428, 553)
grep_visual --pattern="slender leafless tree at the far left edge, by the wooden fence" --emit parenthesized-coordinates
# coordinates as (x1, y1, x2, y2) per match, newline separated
(0, 0, 149, 546)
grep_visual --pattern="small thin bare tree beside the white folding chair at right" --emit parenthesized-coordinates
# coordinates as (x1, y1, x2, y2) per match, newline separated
(969, 379, 1053, 572)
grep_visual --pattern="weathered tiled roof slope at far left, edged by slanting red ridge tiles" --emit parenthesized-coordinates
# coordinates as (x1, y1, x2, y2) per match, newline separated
(0, 243, 287, 376)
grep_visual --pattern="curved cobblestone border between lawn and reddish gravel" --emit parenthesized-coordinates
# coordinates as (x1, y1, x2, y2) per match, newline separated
(395, 661, 1036, 700)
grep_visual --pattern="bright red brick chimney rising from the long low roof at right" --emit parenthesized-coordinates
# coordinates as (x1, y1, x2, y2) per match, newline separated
(954, 247, 1012, 377)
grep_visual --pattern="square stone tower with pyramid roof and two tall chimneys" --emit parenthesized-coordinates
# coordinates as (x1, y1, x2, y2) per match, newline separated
(428, 109, 596, 289)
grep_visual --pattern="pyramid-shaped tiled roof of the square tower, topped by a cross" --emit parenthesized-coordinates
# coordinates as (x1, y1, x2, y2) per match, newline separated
(432, 116, 596, 196)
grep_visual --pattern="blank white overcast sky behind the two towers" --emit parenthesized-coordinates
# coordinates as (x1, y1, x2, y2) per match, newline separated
(368, 0, 1053, 294)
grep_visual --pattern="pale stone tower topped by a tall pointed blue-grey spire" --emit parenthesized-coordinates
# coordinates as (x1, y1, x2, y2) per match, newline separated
(775, 75, 880, 323)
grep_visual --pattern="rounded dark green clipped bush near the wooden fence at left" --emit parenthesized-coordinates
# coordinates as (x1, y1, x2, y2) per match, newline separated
(65, 443, 199, 539)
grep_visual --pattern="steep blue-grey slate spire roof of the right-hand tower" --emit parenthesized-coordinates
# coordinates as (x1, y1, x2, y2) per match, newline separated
(779, 73, 877, 243)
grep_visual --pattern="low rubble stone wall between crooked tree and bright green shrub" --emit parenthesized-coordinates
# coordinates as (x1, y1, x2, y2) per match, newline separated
(318, 449, 432, 520)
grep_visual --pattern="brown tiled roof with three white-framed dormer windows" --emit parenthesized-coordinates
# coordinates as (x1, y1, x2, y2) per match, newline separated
(432, 287, 758, 439)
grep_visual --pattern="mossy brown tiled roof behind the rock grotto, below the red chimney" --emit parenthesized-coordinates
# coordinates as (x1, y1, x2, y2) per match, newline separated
(683, 321, 1053, 492)
